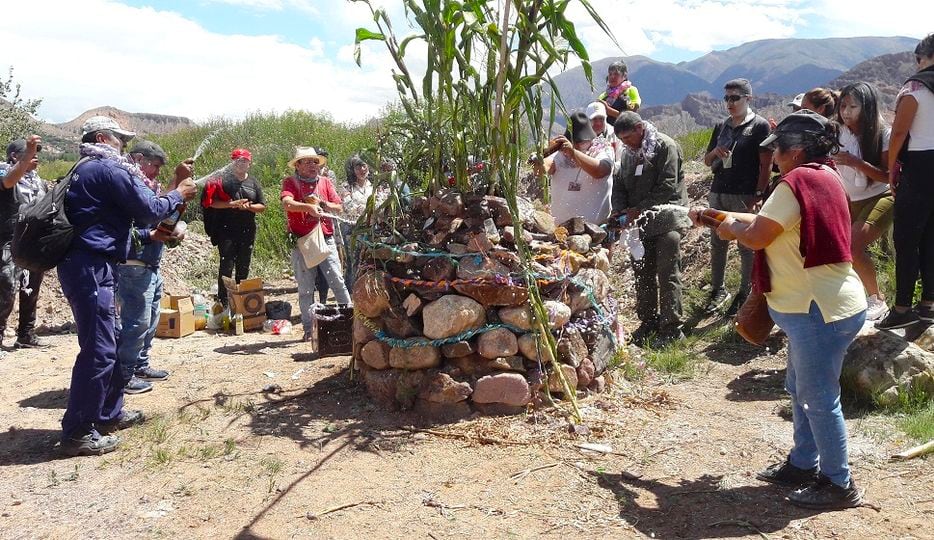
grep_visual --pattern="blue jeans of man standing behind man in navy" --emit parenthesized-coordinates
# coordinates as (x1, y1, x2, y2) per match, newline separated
(117, 264, 162, 380)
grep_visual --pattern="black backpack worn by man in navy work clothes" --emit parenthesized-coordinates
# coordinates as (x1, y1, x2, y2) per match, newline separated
(11, 158, 90, 272)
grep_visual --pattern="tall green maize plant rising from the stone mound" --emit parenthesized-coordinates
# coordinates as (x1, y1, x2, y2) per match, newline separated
(351, 0, 615, 420)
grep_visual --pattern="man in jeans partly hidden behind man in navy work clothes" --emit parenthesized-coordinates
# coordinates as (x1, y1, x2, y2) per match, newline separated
(117, 141, 192, 394)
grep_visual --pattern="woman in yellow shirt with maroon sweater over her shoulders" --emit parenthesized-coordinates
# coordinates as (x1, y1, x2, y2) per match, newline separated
(690, 110, 866, 509)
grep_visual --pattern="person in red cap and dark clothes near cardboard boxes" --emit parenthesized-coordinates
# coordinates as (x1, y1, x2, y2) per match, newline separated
(201, 148, 266, 306)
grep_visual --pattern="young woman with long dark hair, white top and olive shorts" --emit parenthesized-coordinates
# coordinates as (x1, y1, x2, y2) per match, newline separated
(833, 82, 895, 321)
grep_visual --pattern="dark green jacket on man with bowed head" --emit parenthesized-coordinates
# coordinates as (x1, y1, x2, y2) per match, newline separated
(611, 133, 691, 237)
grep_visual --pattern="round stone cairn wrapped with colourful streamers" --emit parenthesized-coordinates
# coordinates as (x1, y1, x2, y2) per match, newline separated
(352, 190, 618, 418)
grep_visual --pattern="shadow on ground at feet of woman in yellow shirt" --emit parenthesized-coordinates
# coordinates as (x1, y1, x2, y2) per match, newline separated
(590, 472, 818, 540)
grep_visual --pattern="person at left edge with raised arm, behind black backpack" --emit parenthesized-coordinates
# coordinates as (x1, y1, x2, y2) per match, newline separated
(0, 135, 48, 348)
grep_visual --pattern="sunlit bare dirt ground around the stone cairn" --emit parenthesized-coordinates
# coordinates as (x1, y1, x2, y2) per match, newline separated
(0, 278, 934, 540)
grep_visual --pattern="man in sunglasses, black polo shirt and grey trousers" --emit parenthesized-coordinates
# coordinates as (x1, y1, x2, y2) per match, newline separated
(703, 79, 772, 315)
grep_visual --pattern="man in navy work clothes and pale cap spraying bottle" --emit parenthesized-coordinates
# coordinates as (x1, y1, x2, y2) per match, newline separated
(58, 116, 197, 455)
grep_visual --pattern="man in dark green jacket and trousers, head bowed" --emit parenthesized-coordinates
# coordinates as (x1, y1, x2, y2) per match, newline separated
(612, 111, 691, 346)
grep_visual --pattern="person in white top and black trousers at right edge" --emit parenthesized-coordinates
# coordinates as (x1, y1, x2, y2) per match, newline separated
(876, 34, 934, 329)
